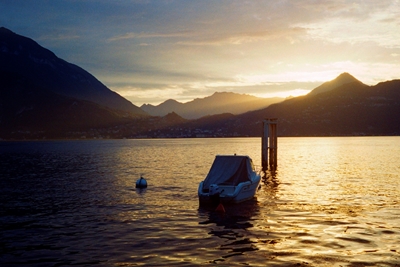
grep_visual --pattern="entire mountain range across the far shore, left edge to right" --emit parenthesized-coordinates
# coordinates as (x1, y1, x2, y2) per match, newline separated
(0, 28, 400, 139)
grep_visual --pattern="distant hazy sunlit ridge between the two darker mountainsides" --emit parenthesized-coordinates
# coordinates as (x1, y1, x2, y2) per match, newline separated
(140, 92, 284, 119)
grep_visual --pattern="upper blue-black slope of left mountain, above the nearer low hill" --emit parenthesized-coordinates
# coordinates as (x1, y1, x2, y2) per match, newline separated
(0, 27, 146, 116)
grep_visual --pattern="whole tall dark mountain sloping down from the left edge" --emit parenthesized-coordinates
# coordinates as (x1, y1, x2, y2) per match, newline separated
(0, 28, 148, 139)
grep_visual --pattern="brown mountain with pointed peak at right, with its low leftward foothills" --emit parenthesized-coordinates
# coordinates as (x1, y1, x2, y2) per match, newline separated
(111, 73, 400, 138)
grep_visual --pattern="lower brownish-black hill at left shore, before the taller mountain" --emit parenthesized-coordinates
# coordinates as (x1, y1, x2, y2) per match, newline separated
(0, 70, 136, 138)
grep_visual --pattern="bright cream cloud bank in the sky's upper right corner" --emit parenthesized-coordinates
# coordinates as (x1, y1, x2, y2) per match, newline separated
(295, 0, 400, 47)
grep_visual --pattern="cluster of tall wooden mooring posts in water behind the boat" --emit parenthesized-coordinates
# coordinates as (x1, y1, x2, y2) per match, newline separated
(261, 119, 278, 171)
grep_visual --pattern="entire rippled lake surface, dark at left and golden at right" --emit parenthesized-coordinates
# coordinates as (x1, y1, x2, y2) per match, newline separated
(0, 137, 400, 266)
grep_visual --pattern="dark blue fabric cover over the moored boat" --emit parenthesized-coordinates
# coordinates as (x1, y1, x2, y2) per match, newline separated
(203, 155, 253, 190)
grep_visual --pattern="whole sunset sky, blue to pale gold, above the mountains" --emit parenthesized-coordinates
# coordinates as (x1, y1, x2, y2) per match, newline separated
(0, 0, 400, 106)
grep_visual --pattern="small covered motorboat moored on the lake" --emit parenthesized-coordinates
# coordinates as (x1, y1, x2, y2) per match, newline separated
(198, 154, 261, 206)
